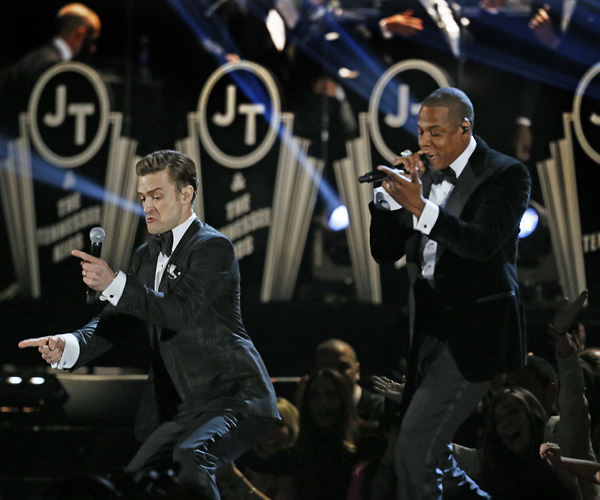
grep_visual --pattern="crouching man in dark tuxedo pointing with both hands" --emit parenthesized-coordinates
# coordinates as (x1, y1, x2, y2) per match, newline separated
(19, 150, 278, 499)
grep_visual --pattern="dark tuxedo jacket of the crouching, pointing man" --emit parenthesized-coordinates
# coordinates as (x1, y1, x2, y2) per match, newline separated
(73, 219, 278, 492)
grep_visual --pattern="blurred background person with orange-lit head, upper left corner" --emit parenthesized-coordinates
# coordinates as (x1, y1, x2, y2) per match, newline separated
(0, 3, 102, 138)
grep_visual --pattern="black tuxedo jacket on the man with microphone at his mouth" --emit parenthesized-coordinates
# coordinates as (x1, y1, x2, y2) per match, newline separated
(370, 139, 531, 382)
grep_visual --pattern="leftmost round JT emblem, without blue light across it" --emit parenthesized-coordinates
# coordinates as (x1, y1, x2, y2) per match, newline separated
(29, 62, 110, 168)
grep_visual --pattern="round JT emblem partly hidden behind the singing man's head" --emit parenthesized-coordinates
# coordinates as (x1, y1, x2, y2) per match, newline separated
(369, 59, 450, 163)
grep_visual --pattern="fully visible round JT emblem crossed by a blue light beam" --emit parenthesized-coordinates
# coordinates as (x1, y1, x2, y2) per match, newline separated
(198, 61, 281, 169)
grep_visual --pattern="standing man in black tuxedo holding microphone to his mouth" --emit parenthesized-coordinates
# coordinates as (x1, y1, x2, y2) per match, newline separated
(370, 88, 531, 500)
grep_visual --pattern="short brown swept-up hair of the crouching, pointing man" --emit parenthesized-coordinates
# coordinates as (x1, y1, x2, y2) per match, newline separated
(135, 149, 198, 202)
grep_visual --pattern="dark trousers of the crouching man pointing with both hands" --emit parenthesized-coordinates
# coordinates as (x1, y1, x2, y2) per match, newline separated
(126, 411, 273, 500)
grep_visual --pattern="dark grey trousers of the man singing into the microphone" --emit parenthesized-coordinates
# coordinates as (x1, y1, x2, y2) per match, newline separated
(395, 336, 489, 500)
